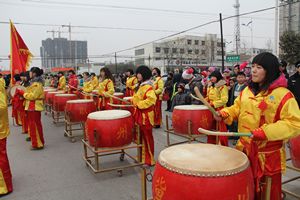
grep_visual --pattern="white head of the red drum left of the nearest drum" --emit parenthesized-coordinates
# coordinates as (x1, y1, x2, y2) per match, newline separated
(88, 110, 131, 120)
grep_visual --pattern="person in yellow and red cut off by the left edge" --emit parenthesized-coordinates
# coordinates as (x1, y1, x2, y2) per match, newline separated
(0, 73, 13, 197)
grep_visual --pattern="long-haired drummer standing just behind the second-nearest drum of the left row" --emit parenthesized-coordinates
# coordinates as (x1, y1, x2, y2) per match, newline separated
(98, 67, 115, 110)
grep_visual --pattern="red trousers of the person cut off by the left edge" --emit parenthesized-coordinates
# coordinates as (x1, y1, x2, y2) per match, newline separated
(0, 138, 13, 195)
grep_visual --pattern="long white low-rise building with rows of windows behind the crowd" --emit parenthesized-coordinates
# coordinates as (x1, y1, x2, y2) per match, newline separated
(135, 34, 225, 72)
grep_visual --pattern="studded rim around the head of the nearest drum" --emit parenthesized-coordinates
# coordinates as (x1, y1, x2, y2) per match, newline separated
(158, 144, 250, 177)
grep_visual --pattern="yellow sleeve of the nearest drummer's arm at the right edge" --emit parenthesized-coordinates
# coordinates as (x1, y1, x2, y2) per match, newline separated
(261, 98, 300, 141)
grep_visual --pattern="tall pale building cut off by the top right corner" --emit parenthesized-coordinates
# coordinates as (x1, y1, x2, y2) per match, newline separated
(279, 0, 300, 36)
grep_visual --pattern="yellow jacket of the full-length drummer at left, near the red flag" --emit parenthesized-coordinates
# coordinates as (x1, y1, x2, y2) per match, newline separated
(23, 82, 44, 111)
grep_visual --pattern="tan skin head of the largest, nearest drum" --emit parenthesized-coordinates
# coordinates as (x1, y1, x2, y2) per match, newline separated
(158, 144, 249, 177)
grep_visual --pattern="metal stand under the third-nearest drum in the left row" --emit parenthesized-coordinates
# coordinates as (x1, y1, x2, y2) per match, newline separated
(64, 111, 85, 143)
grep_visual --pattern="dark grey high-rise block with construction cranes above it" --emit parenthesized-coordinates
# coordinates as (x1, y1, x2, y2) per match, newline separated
(40, 38, 87, 71)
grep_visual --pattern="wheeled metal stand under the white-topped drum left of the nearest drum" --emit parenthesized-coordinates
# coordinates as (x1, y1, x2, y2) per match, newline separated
(81, 126, 143, 176)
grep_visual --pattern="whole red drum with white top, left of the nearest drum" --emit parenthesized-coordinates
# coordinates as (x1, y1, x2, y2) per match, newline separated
(85, 110, 133, 148)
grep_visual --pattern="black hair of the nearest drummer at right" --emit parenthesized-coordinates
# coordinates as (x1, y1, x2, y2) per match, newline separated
(249, 52, 281, 93)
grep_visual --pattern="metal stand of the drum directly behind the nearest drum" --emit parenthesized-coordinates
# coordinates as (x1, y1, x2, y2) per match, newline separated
(165, 115, 203, 147)
